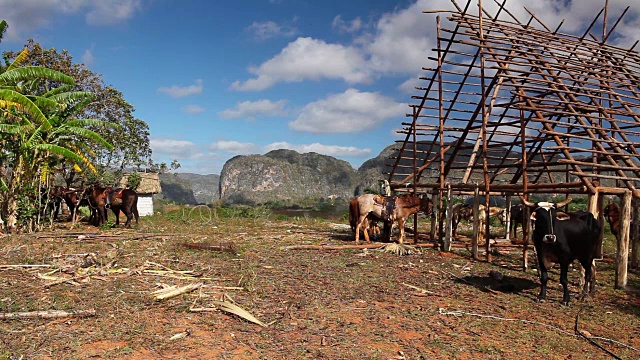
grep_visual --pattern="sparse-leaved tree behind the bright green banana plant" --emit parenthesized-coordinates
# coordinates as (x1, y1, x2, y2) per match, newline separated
(4, 39, 151, 185)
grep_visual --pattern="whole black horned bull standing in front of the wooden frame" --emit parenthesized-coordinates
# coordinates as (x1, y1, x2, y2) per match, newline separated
(521, 197, 600, 305)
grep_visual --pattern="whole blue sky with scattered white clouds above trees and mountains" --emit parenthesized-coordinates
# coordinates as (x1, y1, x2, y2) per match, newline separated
(0, 0, 640, 174)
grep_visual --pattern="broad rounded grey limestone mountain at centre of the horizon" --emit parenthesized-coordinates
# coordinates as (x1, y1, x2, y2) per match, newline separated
(220, 149, 357, 203)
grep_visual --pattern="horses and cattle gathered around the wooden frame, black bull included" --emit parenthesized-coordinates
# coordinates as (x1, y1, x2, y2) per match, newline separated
(349, 194, 613, 305)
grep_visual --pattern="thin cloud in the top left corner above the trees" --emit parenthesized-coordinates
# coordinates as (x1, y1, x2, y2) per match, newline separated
(0, 0, 141, 42)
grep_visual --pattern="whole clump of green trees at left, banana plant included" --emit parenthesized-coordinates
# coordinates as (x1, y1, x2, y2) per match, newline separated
(0, 21, 156, 231)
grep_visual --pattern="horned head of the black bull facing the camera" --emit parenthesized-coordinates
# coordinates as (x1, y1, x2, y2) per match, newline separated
(520, 196, 571, 244)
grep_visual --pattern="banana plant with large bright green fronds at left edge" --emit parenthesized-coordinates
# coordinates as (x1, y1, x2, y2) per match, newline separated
(0, 27, 111, 233)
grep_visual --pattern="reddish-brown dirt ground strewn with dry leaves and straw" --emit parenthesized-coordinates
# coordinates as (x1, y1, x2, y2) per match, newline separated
(0, 214, 640, 359)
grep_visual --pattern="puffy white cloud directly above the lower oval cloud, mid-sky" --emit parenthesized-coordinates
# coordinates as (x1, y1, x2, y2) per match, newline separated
(231, 37, 369, 91)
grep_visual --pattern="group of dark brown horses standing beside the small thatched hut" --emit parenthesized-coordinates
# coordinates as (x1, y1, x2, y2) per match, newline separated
(43, 185, 140, 227)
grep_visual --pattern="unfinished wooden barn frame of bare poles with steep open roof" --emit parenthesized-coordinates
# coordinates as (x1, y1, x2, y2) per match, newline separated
(388, 0, 640, 287)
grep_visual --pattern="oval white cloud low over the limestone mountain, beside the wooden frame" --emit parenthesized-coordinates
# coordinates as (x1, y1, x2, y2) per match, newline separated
(289, 89, 407, 133)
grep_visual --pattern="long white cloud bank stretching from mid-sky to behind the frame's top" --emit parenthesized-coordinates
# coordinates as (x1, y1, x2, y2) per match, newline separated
(231, 0, 640, 90)
